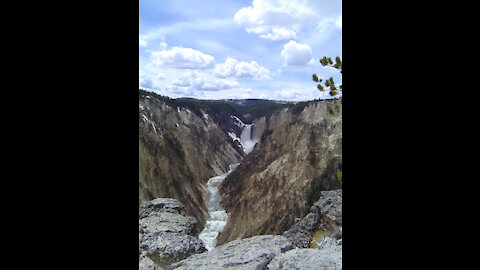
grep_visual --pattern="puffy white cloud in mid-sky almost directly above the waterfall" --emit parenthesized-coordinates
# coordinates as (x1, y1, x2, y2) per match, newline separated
(214, 57, 271, 80)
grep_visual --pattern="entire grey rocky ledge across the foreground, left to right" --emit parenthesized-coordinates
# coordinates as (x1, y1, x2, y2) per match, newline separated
(139, 190, 342, 270)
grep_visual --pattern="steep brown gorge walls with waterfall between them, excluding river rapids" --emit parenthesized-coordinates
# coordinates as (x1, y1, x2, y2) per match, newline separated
(139, 91, 342, 245)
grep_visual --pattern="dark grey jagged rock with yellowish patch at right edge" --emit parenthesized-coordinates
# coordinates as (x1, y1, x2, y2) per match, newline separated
(283, 189, 342, 249)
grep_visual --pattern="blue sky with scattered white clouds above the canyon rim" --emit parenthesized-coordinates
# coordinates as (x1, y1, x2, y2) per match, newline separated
(139, 0, 343, 101)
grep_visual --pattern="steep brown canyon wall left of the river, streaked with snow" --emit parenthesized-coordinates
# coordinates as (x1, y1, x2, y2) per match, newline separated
(139, 93, 243, 230)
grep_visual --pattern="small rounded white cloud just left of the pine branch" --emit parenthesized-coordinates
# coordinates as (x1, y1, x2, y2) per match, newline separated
(280, 40, 314, 66)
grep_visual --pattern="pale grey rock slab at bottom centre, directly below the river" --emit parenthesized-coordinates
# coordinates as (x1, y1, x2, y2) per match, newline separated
(171, 235, 293, 270)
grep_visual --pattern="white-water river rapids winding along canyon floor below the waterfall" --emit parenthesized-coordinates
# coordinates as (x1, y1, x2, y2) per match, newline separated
(198, 163, 240, 250)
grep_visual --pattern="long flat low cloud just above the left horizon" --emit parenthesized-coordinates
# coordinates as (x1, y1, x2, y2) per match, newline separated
(172, 72, 238, 91)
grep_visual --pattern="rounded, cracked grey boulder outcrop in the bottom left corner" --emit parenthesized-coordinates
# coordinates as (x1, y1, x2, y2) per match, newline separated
(138, 198, 206, 269)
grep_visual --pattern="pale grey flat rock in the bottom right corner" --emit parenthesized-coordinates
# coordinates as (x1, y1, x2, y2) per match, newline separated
(266, 248, 342, 270)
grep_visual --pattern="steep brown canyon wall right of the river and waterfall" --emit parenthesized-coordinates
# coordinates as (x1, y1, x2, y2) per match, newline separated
(218, 100, 342, 245)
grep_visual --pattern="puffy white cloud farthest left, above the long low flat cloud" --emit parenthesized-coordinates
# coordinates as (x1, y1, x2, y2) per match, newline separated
(151, 47, 215, 69)
